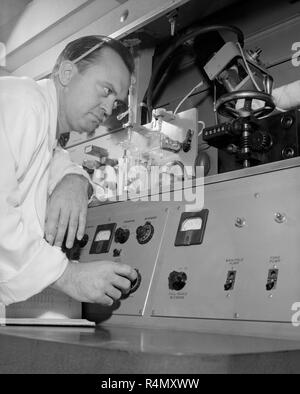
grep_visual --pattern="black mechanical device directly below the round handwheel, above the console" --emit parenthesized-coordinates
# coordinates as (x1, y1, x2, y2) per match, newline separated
(203, 110, 300, 173)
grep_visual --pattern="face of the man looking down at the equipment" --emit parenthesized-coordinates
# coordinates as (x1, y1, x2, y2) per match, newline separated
(62, 48, 130, 133)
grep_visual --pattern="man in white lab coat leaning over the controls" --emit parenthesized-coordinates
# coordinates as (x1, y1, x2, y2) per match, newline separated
(0, 36, 136, 305)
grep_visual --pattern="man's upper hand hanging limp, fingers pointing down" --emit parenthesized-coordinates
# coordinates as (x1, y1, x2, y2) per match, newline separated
(45, 174, 89, 249)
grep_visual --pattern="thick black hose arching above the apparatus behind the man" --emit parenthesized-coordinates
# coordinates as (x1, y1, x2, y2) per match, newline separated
(147, 25, 244, 119)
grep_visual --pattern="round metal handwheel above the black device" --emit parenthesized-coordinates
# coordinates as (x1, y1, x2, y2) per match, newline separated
(216, 90, 275, 119)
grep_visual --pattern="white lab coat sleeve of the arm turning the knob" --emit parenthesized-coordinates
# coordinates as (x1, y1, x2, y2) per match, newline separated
(0, 92, 68, 305)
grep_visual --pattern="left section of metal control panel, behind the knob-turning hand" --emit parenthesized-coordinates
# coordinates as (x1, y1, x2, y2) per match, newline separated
(80, 202, 169, 315)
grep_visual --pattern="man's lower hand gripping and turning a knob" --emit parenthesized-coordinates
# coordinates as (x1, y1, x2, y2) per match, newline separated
(52, 261, 137, 306)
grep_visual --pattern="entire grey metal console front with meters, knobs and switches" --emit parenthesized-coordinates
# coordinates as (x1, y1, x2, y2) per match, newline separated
(81, 159, 300, 336)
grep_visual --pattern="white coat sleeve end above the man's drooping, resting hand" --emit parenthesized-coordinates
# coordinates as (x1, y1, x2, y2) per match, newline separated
(48, 145, 93, 196)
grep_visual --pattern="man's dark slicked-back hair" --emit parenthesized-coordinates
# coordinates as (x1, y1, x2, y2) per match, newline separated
(52, 35, 134, 75)
